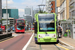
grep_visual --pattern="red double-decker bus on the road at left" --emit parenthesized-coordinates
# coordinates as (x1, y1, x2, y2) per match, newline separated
(15, 19, 25, 33)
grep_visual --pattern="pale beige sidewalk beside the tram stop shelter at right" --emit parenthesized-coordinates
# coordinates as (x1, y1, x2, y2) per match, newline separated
(59, 37, 75, 48)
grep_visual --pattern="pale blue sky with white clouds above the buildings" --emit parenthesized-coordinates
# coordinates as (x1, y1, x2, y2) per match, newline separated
(2, 0, 46, 17)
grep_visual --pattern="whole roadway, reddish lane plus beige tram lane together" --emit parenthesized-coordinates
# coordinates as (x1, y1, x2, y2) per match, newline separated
(0, 31, 70, 50)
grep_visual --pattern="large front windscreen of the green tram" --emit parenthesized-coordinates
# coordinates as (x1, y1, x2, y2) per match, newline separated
(39, 14, 55, 31)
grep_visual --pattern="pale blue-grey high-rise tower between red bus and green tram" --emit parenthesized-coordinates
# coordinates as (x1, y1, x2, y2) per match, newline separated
(24, 7, 33, 28)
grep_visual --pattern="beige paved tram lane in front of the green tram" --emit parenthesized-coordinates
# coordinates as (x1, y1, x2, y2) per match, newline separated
(26, 37, 65, 50)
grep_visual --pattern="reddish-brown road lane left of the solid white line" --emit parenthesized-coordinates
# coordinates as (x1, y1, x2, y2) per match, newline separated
(0, 32, 32, 50)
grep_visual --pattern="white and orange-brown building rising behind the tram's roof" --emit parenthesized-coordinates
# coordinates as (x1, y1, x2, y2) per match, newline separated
(46, 0, 55, 13)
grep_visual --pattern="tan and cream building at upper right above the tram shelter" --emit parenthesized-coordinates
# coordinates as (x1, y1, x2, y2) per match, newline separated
(57, 0, 69, 20)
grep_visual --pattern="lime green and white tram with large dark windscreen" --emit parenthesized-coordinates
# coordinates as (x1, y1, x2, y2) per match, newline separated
(34, 13, 57, 43)
